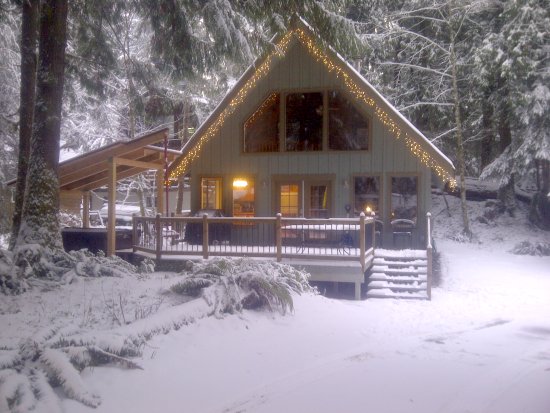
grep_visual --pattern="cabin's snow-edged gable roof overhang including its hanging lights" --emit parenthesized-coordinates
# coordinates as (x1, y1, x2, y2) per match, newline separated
(168, 18, 455, 186)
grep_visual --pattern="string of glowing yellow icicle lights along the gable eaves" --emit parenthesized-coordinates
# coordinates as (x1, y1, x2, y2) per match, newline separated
(170, 28, 456, 187)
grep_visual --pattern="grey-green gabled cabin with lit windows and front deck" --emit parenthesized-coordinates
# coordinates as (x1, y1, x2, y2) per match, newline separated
(148, 19, 454, 297)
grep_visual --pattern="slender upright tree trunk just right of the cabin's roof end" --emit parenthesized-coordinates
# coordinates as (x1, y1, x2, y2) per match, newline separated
(450, 40, 472, 239)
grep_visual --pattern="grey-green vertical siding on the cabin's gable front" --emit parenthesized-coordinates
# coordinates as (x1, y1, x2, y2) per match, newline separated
(191, 37, 429, 220)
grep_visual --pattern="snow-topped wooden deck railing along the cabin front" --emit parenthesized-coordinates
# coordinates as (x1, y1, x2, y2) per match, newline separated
(133, 214, 375, 270)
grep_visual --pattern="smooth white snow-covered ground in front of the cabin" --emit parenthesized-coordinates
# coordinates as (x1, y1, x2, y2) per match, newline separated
(0, 197, 550, 413)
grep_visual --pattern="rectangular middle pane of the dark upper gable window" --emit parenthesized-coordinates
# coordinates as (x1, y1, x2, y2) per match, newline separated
(285, 93, 323, 151)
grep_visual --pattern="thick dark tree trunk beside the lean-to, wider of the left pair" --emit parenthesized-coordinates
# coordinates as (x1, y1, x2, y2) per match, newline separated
(17, 0, 67, 250)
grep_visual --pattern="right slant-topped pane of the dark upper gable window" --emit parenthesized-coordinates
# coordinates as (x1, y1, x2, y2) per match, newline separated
(328, 91, 369, 151)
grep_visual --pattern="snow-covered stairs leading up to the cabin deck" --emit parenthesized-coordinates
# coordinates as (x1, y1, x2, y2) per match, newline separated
(367, 249, 428, 300)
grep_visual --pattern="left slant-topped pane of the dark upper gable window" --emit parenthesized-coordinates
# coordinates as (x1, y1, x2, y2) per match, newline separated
(243, 93, 279, 153)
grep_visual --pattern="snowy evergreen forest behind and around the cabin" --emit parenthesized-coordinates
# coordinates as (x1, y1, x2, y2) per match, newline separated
(0, 0, 550, 249)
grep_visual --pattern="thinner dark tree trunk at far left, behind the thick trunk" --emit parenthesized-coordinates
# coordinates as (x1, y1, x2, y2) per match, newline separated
(9, 0, 40, 250)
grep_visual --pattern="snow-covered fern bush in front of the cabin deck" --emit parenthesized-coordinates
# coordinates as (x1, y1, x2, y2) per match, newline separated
(171, 258, 312, 315)
